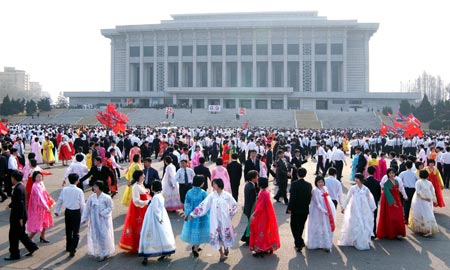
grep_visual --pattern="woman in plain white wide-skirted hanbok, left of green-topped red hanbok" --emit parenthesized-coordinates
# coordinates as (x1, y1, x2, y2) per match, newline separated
(338, 173, 377, 250)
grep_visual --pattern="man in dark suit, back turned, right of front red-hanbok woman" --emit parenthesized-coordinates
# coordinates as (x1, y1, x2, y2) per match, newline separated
(286, 168, 312, 252)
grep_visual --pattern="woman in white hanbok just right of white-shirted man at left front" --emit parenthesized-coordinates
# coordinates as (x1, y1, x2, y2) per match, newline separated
(81, 181, 115, 261)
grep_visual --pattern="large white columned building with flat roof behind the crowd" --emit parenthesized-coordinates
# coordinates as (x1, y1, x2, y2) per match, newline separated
(65, 12, 420, 110)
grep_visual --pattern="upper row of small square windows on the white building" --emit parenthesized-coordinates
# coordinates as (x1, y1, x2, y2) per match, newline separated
(130, 43, 343, 57)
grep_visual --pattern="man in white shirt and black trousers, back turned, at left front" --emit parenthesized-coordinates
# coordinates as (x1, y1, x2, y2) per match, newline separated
(55, 173, 85, 257)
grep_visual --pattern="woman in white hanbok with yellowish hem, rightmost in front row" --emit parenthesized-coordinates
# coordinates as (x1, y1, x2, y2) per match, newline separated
(408, 170, 439, 237)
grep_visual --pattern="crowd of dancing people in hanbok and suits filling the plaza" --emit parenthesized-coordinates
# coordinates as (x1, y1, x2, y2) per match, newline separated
(0, 125, 450, 265)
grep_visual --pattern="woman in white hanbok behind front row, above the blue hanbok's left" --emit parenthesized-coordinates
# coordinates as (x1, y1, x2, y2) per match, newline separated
(162, 157, 183, 211)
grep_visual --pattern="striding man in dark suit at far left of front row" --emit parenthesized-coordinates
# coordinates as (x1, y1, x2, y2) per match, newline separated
(5, 171, 39, 261)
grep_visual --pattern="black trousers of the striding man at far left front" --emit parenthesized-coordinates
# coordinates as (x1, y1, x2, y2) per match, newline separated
(9, 220, 38, 258)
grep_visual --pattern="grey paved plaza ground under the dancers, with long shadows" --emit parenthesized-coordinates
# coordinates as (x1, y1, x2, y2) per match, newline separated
(0, 158, 450, 270)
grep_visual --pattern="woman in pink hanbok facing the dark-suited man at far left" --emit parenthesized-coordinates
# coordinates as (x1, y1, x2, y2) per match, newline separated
(27, 171, 55, 243)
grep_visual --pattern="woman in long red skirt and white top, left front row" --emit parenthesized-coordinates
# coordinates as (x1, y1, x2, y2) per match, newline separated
(119, 170, 151, 253)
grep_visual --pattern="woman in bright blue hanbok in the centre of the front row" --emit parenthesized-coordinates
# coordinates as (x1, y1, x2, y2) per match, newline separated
(181, 175, 209, 257)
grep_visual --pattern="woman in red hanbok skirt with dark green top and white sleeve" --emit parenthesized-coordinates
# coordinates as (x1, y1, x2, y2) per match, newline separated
(377, 168, 408, 239)
